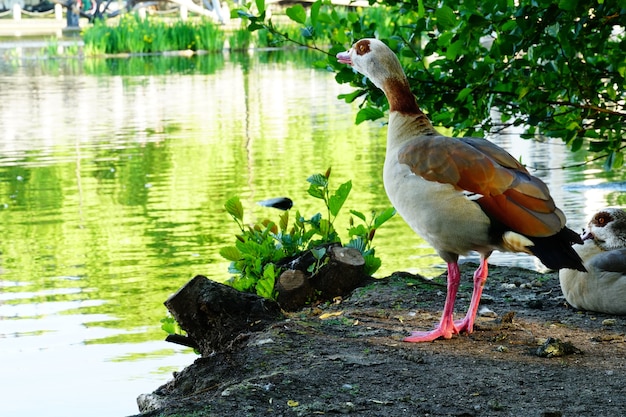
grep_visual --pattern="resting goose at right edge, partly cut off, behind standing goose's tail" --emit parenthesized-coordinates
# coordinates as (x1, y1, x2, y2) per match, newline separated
(559, 208, 626, 314)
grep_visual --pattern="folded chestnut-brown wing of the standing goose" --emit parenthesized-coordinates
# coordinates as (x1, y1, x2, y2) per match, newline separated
(398, 136, 565, 237)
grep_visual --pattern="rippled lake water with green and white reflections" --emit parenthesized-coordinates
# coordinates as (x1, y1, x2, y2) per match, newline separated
(0, 46, 626, 417)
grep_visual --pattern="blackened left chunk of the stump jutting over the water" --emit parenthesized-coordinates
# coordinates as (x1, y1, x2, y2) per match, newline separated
(165, 275, 283, 356)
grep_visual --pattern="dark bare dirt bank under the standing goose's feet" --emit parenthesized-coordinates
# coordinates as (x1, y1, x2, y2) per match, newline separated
(133, 265, 626, 417)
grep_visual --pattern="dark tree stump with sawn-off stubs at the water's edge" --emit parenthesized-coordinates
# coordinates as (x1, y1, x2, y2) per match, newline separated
(165, 244, 372, 356)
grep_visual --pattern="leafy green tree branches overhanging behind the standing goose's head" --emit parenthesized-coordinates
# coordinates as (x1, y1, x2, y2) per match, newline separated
(237, 0, 626, 169)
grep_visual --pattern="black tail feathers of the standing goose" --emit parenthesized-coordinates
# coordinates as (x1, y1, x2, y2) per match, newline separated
(529, 227, 587, 272)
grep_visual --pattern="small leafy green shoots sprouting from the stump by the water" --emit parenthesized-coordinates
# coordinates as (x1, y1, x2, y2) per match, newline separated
(220, 169, 395, 299)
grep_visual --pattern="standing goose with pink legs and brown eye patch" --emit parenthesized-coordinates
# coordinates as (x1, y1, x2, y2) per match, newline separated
(337, 39, 585, 342)
